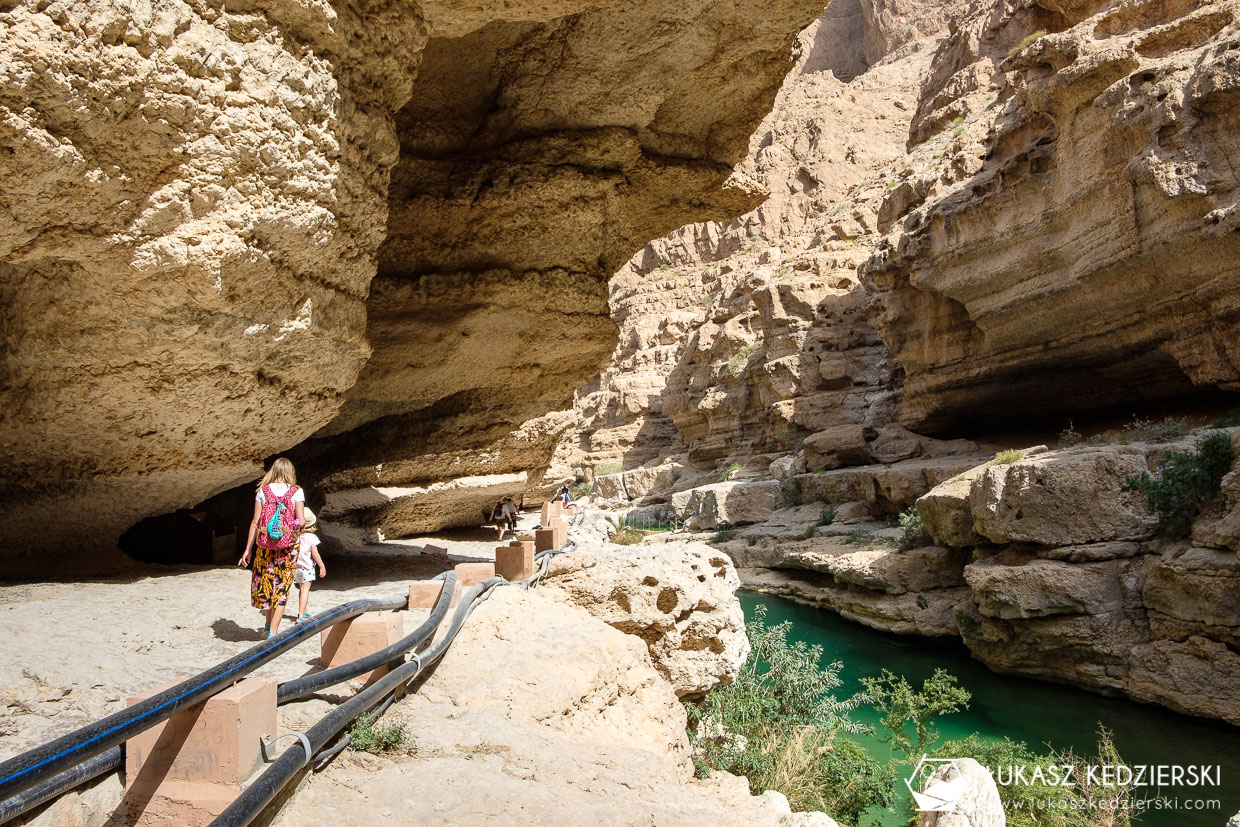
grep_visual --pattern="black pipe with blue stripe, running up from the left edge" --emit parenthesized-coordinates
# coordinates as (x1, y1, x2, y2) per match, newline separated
(0, 592, 404, 807)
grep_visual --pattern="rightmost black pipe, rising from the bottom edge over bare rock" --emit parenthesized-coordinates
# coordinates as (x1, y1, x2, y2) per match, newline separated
(211, 577, 506, 827)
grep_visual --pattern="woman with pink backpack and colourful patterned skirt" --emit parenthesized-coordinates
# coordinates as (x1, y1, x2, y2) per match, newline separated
(237, 456, 306, 639)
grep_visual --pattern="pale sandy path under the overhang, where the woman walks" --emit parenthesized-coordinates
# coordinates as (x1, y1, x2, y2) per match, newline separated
(0, 511, 538, 759)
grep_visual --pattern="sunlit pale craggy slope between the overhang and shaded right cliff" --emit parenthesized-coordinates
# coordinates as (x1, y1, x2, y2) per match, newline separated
(540, 0, 960, 490)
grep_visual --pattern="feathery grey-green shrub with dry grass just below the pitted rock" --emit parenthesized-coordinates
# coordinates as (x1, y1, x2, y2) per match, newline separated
(686, 608, 897, 823)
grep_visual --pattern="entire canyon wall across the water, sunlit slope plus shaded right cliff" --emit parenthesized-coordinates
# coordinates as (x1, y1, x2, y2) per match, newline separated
(552, 1, 1240, 490)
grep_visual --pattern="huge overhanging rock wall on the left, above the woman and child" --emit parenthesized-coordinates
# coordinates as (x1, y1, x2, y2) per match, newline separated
(0, 0, 821, 565)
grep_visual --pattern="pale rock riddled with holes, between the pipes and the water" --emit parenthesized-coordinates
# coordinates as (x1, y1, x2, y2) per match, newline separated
(543, 542, 749, 697)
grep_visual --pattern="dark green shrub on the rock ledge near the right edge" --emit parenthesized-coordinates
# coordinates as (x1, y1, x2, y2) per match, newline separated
(1128, 434, 1231, 537)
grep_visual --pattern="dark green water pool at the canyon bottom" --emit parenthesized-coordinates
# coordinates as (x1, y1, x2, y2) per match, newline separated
(739, 591, 1240, 827)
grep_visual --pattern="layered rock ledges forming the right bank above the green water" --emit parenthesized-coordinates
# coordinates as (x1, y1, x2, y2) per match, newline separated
(720, 440, 1240, 723)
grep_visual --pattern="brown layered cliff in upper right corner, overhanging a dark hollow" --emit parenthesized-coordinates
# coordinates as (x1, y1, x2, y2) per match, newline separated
(861, 2, 1240, 429)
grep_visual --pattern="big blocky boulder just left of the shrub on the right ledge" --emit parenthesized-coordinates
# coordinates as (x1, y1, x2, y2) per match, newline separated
(970, 448, 1157, 546)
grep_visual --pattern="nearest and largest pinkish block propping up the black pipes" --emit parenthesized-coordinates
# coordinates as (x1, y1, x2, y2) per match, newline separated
(122, 678, 277, 827)
